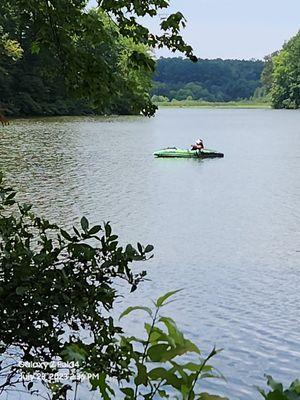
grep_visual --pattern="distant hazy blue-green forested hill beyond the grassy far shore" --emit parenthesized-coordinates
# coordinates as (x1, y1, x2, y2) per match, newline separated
(152, 58, 264, 102)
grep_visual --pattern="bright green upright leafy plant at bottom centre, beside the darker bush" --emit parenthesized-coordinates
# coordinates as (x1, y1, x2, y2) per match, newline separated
(112, 290, 225, 400)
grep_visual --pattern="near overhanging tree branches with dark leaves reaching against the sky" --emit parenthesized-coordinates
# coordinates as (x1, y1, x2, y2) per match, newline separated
(0, 0, 196, 115)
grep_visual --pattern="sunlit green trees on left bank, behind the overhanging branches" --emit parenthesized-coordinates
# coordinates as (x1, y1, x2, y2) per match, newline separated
(0, 5, 155, 115)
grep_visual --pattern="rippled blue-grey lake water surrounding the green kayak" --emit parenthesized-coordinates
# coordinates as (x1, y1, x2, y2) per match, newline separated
(0, 109, 300, 400)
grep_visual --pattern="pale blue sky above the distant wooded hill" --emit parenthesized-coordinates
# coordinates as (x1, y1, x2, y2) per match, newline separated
(91, 0, 300, 59)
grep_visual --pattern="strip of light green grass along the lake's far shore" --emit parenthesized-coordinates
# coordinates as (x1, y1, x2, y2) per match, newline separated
(155, 100, 271, 108)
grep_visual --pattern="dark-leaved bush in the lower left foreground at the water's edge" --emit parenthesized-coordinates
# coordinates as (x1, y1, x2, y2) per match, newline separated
(0, 176, 153, 394)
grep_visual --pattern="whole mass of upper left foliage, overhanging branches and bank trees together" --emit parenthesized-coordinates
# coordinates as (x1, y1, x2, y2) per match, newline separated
(0, 0, 196, 115)
